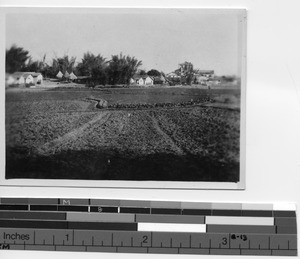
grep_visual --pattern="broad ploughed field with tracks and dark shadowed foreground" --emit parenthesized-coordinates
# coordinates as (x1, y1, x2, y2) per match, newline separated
(6, 88, 240, 182)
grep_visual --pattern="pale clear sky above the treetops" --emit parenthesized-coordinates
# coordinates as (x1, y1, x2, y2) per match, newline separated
(6, 9, 242, 75)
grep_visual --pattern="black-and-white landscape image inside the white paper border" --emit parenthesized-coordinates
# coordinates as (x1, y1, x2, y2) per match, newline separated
(3, 8, 246, 189)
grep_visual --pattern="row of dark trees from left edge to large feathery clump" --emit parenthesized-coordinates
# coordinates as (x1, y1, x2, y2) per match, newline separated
(6, 45, 149, 85)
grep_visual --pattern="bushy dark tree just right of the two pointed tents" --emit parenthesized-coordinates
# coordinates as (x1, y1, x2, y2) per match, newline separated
(76, 52, 107, 85)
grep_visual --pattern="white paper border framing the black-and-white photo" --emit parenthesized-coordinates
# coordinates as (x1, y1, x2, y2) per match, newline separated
(0, 6, 247, 190)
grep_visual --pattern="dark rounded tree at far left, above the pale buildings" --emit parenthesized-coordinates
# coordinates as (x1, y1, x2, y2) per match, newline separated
(5, 45, 30, 73)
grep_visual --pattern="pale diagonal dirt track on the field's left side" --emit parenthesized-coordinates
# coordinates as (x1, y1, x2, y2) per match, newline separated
(38, 111, 111, 154)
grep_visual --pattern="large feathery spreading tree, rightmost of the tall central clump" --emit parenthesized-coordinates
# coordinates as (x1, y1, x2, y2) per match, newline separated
(107, 53, 142, 85)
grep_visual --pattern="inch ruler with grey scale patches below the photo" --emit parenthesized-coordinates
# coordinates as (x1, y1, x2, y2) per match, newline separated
(0, 198, 297, 256)
